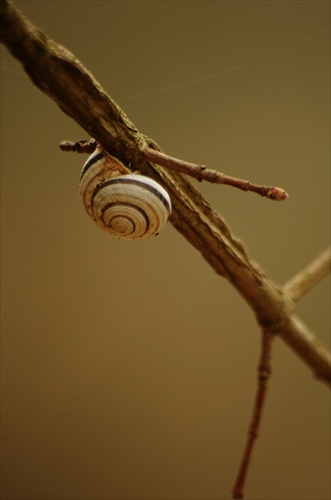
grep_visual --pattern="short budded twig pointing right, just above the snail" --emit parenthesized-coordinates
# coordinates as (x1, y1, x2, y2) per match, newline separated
(142, 148, 288, 201)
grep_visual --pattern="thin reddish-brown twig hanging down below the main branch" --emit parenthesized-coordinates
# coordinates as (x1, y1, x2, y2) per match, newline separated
(232, 331, 274, 498)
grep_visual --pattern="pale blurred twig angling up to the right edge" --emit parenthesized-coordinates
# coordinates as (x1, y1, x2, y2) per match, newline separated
(283, 247, 331, 302)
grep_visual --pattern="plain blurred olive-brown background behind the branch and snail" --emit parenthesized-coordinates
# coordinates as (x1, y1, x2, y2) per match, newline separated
(1, 0, 330, 500)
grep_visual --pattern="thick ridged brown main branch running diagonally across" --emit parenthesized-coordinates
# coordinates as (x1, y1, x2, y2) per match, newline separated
(0, 0, 331, 384)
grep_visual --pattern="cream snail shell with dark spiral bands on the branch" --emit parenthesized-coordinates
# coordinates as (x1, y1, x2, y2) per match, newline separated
(79, 146, 171, 240)
